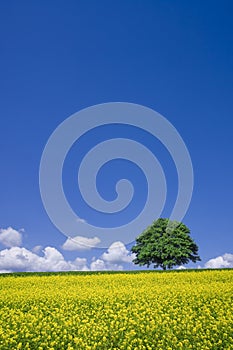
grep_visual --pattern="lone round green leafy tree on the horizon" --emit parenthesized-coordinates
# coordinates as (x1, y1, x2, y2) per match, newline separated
(131, 218, 201, 270)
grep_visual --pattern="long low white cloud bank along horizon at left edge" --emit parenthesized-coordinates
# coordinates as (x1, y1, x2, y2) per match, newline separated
(0, 247, 88, 272)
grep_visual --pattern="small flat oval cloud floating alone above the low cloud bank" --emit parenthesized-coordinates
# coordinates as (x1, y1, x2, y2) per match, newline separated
(62, 236, 100, 251)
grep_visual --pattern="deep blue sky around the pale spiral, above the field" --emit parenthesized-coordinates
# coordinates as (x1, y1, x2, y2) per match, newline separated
(0, 0, 233, 270)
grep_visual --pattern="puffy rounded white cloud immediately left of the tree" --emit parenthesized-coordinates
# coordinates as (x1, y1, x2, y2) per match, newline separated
(102, 242, 134, 263)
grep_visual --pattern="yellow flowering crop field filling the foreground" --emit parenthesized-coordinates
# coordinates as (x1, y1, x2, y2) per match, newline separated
(0, 270, 233, 350)
